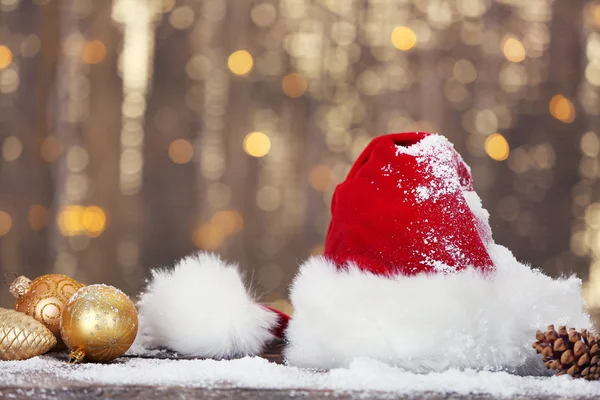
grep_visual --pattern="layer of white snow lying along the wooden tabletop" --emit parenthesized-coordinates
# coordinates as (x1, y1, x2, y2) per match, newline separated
(0, 356, 600, 398)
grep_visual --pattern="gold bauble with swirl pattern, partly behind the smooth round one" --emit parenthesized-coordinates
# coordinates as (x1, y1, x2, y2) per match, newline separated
(10, 274, 83, 350)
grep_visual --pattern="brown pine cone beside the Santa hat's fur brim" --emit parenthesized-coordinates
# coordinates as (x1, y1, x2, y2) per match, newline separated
(532, 325, 600, 381)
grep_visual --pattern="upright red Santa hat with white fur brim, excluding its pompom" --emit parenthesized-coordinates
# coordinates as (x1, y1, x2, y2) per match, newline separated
(286, 132, 589, 371)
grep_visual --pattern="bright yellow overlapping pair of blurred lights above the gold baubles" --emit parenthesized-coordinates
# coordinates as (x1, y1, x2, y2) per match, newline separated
(57, 205, 106, 237)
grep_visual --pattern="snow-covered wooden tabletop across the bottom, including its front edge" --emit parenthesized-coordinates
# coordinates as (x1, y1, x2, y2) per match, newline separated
(0, 354, 600, 399)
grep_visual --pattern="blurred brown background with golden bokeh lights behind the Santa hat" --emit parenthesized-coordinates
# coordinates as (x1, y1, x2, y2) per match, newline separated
(0, 0, 600, 318)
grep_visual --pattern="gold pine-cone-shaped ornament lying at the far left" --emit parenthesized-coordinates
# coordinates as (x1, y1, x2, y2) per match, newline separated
(0, 308, 56, 361)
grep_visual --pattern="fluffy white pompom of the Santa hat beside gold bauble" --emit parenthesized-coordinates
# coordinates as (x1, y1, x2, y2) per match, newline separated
(138, 253, 278, 359)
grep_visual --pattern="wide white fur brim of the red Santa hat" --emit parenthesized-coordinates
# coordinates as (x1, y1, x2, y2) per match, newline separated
(286, 244, 590, 372)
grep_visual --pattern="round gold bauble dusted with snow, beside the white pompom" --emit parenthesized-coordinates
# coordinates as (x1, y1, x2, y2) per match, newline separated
(61, 285, 138, 363)
